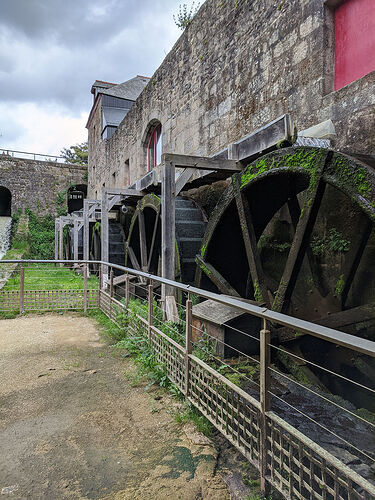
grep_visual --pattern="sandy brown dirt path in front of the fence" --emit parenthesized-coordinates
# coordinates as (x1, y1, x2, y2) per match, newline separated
(0, 315, 229, 500)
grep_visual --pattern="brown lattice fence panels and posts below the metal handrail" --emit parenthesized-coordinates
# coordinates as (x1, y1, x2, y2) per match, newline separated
(0, 263, 375, 500)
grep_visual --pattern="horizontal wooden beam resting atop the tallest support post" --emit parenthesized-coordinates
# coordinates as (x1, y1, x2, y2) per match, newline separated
(162, 153, 243, 173)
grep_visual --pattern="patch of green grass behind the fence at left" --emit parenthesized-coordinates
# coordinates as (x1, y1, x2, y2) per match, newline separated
(4, 264, 98, 290)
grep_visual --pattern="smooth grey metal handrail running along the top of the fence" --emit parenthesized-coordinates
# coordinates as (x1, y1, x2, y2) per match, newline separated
(0, 260, 375, 357)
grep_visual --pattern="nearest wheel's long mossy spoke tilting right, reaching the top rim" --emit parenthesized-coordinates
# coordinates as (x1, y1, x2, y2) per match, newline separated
(272, 153, 331, 312)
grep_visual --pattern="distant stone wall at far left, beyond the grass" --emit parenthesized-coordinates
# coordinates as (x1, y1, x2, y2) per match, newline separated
(0, 155, 87, 215)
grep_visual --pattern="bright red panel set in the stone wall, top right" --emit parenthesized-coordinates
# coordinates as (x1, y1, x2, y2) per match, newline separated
(335, 0, 375, 90)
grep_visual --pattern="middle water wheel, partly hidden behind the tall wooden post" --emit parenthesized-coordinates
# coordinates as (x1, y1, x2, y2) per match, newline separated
(126, 194, 206, 283)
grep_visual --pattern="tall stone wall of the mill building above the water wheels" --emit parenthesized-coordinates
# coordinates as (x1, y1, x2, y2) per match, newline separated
(89, 0, 375, 198)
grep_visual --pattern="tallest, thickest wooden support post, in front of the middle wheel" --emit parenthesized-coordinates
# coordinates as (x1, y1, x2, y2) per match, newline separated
(161, 162, 178, 321)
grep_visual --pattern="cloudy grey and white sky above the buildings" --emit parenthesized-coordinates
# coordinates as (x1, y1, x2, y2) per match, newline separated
(0, 0, 183, 155)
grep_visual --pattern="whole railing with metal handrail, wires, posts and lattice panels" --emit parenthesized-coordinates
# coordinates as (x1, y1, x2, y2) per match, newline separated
(0, 260, 375, 500)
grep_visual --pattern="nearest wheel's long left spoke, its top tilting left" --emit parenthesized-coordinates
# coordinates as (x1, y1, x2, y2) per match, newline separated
(236, 189, 270, 306)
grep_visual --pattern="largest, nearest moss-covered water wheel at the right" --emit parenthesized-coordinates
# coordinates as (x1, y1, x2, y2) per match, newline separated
(196, 148, 375, 410)
